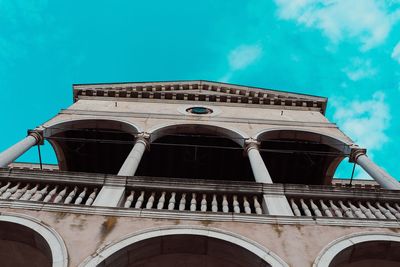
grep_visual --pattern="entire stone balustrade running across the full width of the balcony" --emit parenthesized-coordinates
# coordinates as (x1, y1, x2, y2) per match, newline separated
(0, 169, 400, 221)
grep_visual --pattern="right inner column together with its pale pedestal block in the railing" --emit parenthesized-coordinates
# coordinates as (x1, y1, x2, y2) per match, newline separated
(245, 138, 293, 216)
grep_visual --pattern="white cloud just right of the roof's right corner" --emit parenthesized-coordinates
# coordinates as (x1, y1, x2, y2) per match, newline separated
(333, 91, 390, 153)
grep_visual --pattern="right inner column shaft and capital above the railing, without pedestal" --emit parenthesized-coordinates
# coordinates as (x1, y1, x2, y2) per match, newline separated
(245, 138, 272, 184)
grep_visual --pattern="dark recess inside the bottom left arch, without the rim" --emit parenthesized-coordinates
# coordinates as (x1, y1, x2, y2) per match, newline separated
(0, 222, 52, 267)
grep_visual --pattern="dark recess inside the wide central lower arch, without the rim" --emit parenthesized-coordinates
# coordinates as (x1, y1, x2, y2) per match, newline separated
(97, 235, 271, 267)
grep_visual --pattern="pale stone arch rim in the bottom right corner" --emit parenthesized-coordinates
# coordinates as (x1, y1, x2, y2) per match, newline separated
(313, 232, 400, 267)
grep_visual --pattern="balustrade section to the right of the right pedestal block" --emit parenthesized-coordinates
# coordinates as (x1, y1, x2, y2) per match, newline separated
(285, 185, 400, 220)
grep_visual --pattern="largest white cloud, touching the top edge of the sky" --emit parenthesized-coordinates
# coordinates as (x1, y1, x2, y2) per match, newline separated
(275, 0, 399, 51)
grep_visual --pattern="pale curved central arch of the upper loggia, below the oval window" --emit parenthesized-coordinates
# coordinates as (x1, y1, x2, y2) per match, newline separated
(148, 123, 249, 147)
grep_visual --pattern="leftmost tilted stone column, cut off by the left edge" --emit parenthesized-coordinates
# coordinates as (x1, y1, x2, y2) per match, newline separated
(0, 131, 43, 168)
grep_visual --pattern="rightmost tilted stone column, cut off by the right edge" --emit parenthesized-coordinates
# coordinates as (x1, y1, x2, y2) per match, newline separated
(350, 148, 400, 190)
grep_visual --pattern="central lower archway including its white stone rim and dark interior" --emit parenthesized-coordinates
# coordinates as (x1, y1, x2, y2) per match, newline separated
(79, 227, 288, 267)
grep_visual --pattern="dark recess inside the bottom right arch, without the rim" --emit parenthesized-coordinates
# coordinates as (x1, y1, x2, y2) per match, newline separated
(329, 241, 400, 267)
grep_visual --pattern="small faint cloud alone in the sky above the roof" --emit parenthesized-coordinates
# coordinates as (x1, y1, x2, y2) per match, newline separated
(228, 44, 262, 70)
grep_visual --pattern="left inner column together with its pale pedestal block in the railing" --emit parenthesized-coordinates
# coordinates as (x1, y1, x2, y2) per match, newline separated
(93, 133, 149, 207)
